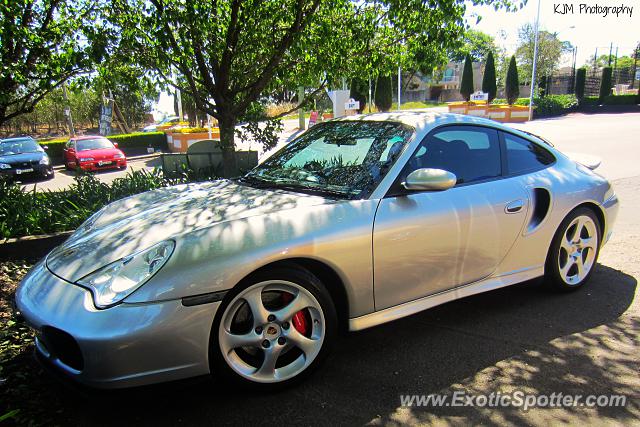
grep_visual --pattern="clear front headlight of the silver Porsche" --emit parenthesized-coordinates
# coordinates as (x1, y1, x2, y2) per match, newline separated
(78, 240, 175, 308)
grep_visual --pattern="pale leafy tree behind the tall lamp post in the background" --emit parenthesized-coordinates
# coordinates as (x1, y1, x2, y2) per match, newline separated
(516, 24, 573, 81)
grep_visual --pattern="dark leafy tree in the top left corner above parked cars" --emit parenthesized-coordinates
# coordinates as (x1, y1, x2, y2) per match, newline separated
(0, 0, 111, 126)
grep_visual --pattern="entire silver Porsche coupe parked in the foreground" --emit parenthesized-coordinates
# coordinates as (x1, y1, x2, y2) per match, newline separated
(16, 112, 618, 388)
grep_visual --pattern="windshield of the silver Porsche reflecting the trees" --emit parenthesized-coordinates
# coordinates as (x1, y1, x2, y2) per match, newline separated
(242, 121, 413, 199)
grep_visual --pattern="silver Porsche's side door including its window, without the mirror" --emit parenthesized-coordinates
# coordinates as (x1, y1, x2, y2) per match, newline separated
(373, 125, 529, 310)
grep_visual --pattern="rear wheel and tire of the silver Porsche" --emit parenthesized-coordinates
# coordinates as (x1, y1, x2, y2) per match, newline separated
(545, 207, 602, 291)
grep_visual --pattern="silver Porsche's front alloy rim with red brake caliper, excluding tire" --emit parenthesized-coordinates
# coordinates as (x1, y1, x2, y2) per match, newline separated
(218, 280, 325, 383)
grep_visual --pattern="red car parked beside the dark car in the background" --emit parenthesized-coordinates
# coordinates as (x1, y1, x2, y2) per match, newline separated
(64, 136, 127, 171)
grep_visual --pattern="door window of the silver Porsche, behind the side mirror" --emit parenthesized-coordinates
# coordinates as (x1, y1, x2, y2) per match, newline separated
(403, 126, 502, 184)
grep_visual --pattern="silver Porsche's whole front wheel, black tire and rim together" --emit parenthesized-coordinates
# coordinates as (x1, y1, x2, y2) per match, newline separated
(209, 266, 338, 390)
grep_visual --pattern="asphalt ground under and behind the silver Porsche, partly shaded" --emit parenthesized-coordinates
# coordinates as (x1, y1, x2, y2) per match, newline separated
(22, 114, 640, 426)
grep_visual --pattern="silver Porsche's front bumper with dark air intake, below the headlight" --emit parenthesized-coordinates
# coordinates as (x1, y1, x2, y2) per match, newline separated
(16, 261, 220, 388)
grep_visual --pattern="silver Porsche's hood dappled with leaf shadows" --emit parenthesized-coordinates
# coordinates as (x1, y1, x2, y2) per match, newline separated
(47, 180, 329, 282)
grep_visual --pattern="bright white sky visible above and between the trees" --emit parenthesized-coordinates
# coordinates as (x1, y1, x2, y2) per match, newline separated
(155, 0, 640, 119)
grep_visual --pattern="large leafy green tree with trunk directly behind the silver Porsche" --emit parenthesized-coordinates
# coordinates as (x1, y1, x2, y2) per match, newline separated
(109, 0, 511, 173)
